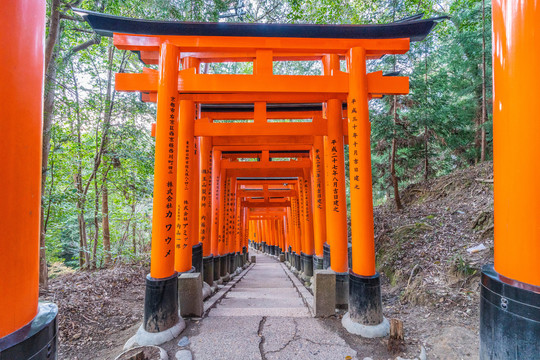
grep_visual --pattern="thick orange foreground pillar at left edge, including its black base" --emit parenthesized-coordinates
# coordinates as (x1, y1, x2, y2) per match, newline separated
(0, 0, 58, 359)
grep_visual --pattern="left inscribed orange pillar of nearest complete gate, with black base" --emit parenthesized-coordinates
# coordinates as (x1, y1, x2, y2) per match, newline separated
(142, 42, 183, 333)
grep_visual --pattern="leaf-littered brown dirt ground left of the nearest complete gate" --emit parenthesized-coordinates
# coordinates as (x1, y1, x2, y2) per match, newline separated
(40, 264, 149, 360)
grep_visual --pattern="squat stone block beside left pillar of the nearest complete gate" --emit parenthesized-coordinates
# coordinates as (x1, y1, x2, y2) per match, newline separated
(178, 273, 204, 317)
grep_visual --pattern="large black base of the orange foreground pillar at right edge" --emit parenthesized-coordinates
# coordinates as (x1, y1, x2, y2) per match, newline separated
(480, 264, 540, 360)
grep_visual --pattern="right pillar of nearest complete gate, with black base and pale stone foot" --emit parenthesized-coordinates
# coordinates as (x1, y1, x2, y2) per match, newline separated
(343, 47, 390, 337)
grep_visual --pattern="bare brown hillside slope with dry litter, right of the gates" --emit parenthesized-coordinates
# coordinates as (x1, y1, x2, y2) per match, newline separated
(374, 162, 493, 359)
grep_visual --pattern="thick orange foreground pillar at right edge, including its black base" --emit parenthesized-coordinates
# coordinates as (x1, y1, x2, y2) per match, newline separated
(480, 0, 540, 360)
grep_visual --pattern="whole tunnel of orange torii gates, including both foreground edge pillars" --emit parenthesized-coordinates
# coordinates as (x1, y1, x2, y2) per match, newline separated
(0, 0, 540, 360)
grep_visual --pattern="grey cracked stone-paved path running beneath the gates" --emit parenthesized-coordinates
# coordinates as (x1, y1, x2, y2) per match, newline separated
(190, 255, 356, 360)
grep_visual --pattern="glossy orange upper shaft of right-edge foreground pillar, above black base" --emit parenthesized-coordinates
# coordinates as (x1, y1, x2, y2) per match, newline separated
(493, 0, 540, 286)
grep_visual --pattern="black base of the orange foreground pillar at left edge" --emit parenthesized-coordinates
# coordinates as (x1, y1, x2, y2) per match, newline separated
(0, 302, 58, 360)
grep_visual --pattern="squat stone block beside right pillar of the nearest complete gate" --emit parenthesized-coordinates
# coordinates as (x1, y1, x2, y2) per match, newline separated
(313, 270, 336, 317)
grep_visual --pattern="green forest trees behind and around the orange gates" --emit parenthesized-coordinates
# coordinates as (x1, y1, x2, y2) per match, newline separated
(40, 0, 492, 287)
